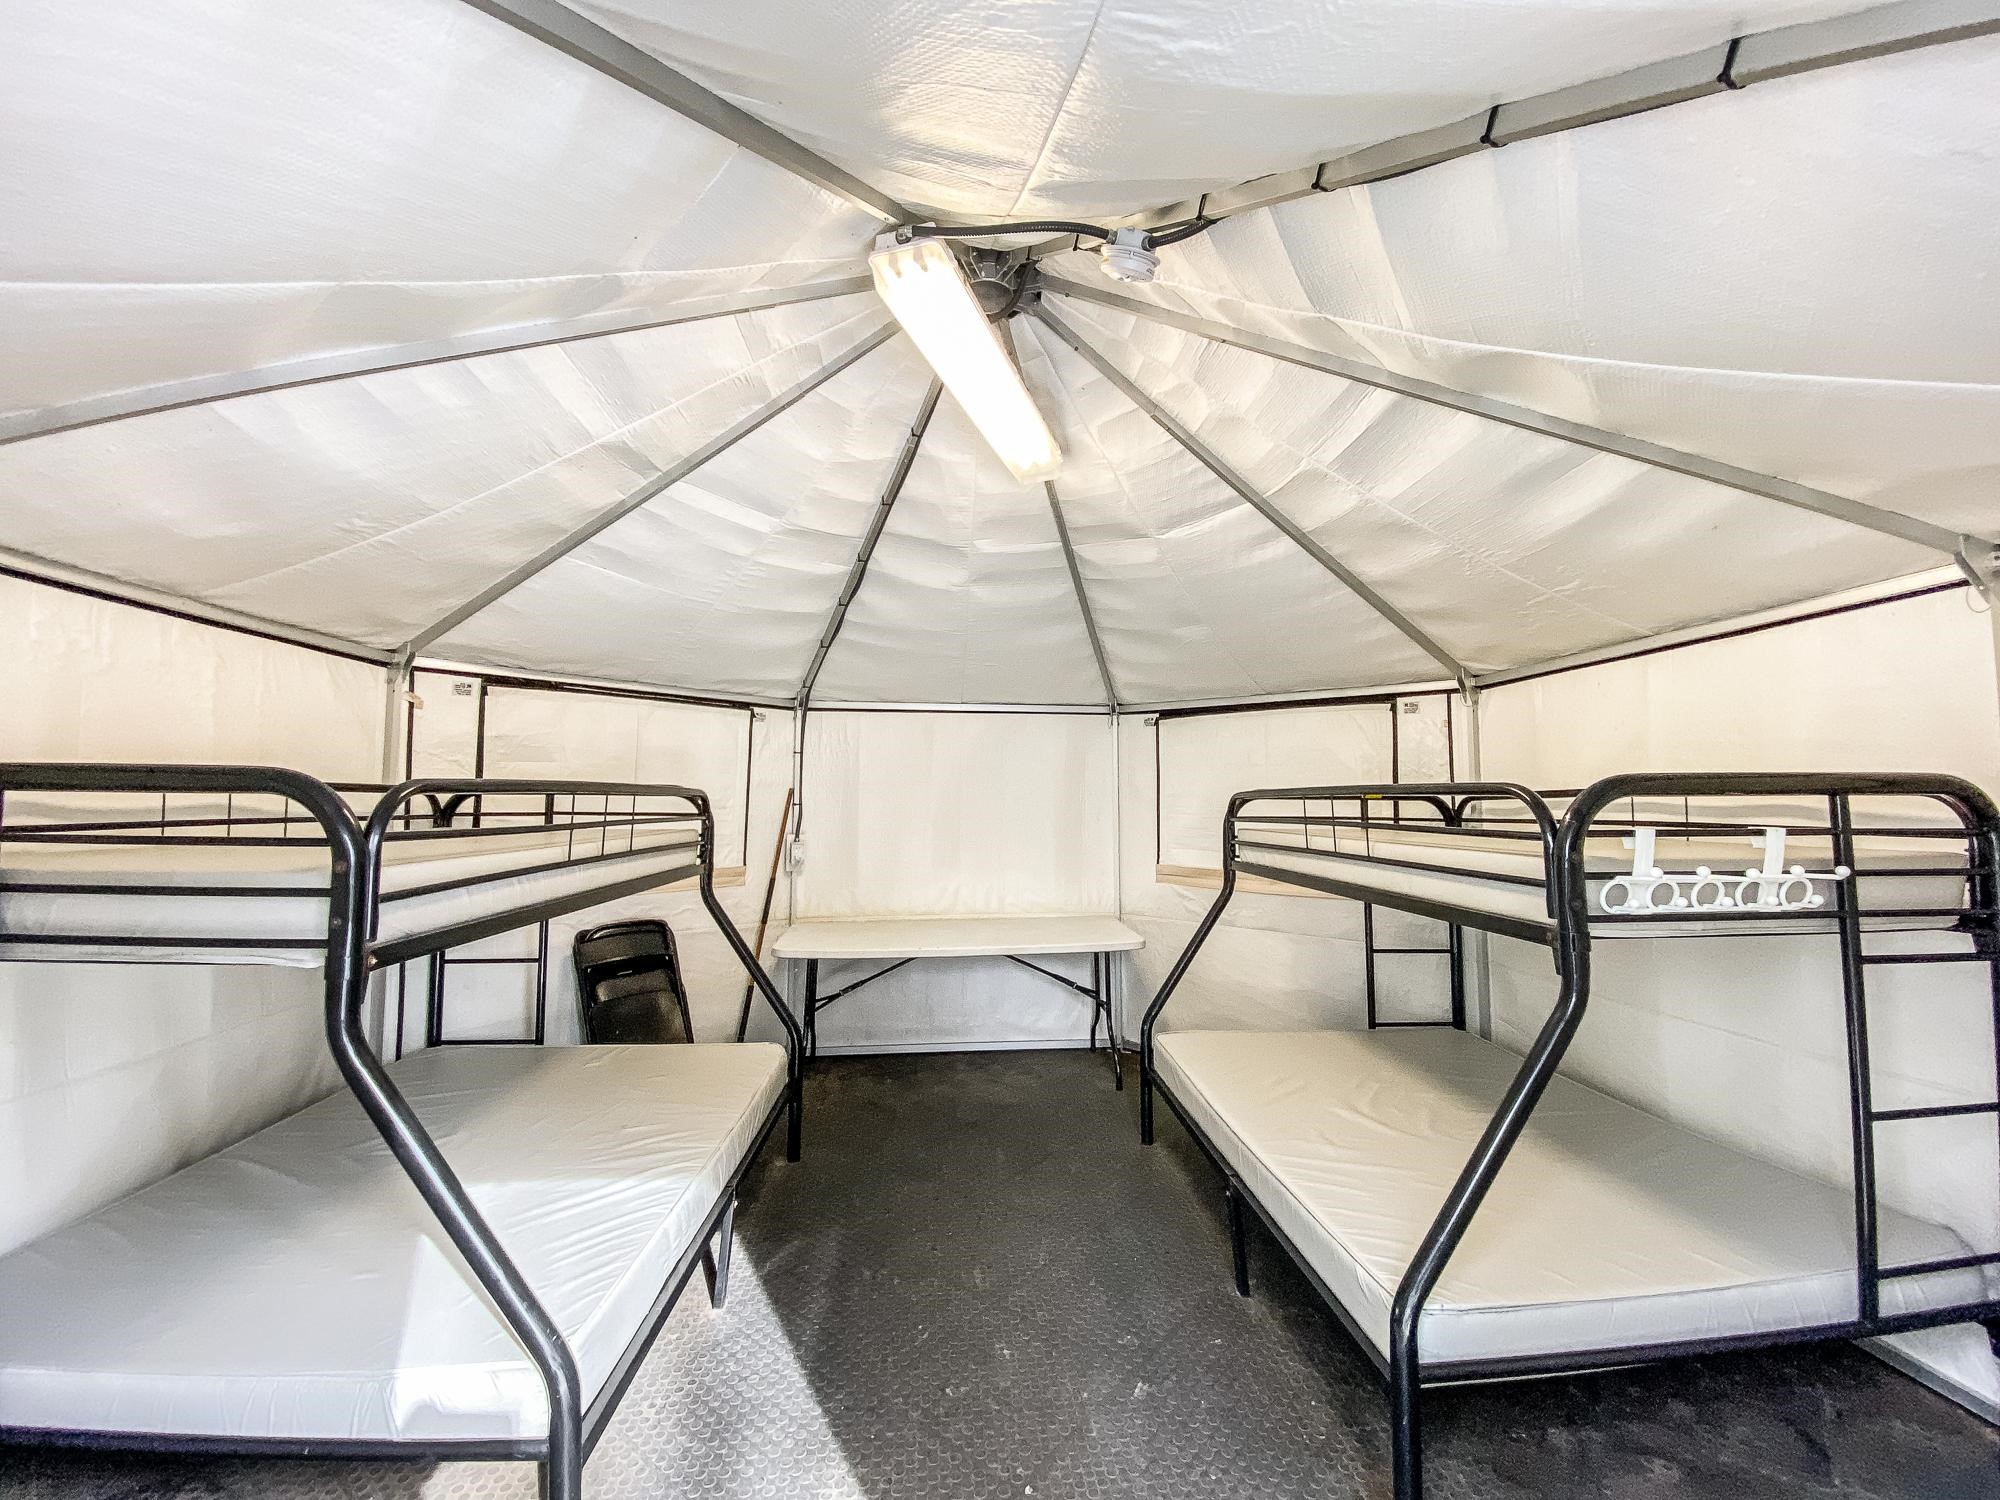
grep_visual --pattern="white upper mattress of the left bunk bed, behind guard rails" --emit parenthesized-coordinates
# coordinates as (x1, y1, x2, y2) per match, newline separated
(0, 824, 698, 968)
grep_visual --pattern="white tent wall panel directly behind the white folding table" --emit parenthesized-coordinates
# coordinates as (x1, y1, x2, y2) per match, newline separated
(792, 708, 1118, 1052)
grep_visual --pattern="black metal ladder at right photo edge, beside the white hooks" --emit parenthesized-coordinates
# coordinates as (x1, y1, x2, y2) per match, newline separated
(1828, 794, 2000, 1354)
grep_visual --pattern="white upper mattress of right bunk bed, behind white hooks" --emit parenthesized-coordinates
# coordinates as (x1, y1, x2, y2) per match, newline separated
(1240, 824, 1964, 938)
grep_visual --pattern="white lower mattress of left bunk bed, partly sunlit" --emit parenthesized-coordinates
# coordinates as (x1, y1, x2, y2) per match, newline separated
(0, 1042, 786, 1440)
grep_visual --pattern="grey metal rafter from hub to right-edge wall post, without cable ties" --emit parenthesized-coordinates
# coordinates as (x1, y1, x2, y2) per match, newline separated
(1042, 276, 1966, 556)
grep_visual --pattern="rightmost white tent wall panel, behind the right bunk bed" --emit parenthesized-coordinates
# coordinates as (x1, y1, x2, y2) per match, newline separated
(1480, 588, 2000, 1414)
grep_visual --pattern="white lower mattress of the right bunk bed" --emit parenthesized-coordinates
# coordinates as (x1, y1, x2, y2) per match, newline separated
(1154, 1028, 1986, 1362)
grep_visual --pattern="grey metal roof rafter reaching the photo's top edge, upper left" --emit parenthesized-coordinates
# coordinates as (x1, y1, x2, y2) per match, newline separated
(464, 0, 920, 224)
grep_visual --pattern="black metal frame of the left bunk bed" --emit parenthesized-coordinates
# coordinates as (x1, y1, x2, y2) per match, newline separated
(0, 762, 804, 1500)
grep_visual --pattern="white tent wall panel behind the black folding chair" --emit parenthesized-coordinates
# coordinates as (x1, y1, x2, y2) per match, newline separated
(402, 670, 792, 1052)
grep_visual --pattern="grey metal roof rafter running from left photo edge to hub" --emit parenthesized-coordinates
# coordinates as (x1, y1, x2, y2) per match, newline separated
(0, 276, 872, 444)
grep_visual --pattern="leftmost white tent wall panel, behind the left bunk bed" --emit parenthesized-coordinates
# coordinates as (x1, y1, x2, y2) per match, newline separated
(0, 578, 384, 1250)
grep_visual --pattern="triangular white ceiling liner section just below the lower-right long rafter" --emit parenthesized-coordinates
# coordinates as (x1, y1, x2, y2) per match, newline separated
(1058, 298, 1936, 670)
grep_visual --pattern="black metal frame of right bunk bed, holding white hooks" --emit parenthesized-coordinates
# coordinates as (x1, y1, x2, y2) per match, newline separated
(1140, 772, 2000, 1500)
